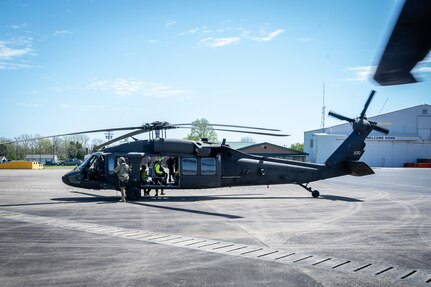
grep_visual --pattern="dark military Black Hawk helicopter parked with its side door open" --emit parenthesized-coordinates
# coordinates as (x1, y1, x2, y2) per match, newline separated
(3, 91, 389, 200)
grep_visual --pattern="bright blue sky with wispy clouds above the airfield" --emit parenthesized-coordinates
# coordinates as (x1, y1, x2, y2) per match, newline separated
(0, 0, 431, 145)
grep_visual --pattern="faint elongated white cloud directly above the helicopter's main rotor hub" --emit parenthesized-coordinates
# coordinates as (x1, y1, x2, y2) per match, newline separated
(89, 79, 190, 97)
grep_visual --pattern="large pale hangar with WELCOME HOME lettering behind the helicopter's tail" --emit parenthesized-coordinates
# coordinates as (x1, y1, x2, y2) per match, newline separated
(304, 104, 431, 167)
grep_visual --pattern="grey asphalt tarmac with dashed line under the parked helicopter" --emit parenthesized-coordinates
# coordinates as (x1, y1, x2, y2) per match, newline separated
(0, 168, 431, 287)
